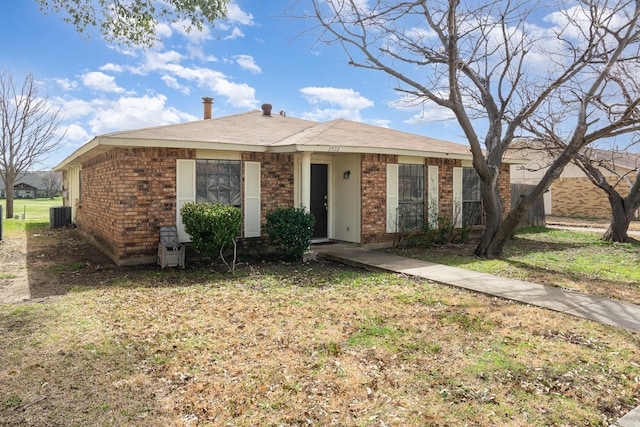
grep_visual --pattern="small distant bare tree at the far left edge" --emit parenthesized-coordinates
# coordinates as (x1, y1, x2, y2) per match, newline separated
(0, 69, 64, 218)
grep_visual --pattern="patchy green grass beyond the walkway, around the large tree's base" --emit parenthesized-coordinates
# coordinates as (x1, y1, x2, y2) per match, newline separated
(396, 227, 640, 304)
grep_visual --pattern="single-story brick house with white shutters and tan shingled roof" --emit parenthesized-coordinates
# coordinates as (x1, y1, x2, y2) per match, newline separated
(55, 98, 510, 265)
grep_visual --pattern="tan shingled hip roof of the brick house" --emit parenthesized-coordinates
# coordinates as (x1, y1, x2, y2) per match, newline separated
(55, 111, 502, 170)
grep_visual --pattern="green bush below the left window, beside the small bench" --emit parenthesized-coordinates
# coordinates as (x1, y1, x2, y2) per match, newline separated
(180, 203, 242, 271)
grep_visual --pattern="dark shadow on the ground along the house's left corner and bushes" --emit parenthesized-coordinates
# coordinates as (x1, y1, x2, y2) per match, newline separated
(26, 223, 350, 299)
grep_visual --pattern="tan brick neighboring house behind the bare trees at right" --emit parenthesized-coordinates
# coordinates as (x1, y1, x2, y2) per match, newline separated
(509, 143, 640, 218)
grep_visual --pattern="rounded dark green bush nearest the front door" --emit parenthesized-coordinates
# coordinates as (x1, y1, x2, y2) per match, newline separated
(264, 206, 316, 261)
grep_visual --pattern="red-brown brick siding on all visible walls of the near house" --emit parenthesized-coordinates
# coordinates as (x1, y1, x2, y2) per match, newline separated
(76, 148, 512, 265)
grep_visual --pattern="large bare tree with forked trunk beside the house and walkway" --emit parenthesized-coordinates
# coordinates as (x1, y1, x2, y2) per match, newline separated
(310, 0, 640, 258)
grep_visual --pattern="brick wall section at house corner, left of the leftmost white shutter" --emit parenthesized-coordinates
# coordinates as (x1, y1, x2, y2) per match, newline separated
(77, 148, 195, 265)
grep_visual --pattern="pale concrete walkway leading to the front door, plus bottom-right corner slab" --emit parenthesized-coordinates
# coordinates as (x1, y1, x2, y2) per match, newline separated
(312, 243, 640, 427)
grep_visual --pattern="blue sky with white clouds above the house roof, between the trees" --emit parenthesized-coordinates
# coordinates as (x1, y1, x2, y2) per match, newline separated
(0, 0, 464, 169)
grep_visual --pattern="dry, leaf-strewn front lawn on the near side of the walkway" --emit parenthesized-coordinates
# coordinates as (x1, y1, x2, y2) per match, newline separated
(0, 226, 640, 426)
